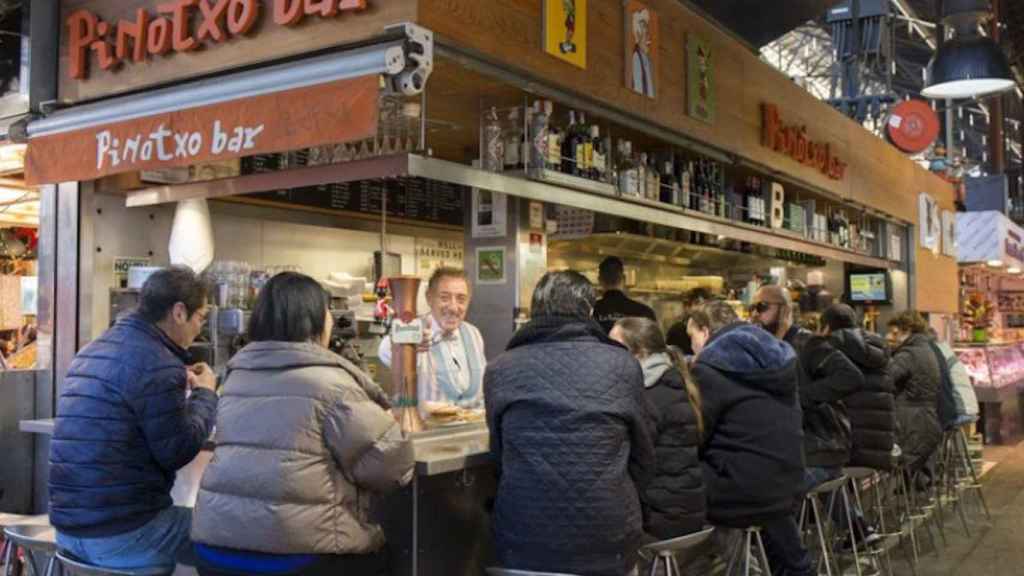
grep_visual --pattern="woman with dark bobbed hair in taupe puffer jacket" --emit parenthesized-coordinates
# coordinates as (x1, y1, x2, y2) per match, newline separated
(193, 273, 413, 576)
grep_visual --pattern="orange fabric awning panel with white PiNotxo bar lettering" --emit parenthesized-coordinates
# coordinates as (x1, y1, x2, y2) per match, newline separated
(26, 75, 380, 184)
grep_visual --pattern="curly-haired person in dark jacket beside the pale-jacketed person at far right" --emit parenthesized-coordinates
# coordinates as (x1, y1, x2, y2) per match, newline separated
(888, 311, 942, 472)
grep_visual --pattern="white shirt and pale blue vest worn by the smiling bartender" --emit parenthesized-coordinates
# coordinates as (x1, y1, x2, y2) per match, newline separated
(377, 314, 487, 416)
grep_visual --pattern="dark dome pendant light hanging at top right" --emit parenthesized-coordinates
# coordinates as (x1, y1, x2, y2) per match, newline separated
(921, 0, 1015, 99)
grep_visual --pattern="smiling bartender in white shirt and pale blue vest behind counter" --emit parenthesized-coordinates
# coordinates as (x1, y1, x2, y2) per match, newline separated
(377, 268, 487, 418)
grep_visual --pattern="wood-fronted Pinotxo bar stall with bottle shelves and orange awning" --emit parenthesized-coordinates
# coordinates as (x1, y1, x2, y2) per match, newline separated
(14, 0, 956, 575)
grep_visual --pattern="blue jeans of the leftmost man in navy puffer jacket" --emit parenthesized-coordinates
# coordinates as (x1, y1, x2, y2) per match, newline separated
(57, 506, 193, 569)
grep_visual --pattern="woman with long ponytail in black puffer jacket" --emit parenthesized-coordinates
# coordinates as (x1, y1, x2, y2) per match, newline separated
(610, 311, 705, 541)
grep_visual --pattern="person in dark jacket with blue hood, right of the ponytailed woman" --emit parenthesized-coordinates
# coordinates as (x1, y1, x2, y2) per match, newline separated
(690, 302, 814, 576)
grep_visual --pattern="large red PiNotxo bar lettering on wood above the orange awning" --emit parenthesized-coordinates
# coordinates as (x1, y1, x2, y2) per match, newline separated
(67, 0, 367, 80)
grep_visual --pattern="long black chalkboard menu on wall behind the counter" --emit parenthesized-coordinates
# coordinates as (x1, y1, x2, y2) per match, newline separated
(248, 177, 469, 227)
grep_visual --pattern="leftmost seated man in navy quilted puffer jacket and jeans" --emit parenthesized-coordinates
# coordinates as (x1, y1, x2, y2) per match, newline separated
(49, 268, 217, 568)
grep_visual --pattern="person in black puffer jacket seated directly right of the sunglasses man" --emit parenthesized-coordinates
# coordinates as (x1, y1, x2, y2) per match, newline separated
(821, 304, 896, 470)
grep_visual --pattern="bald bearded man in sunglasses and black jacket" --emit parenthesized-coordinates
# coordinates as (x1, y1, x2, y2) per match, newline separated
(751, 286, 864, 492)
